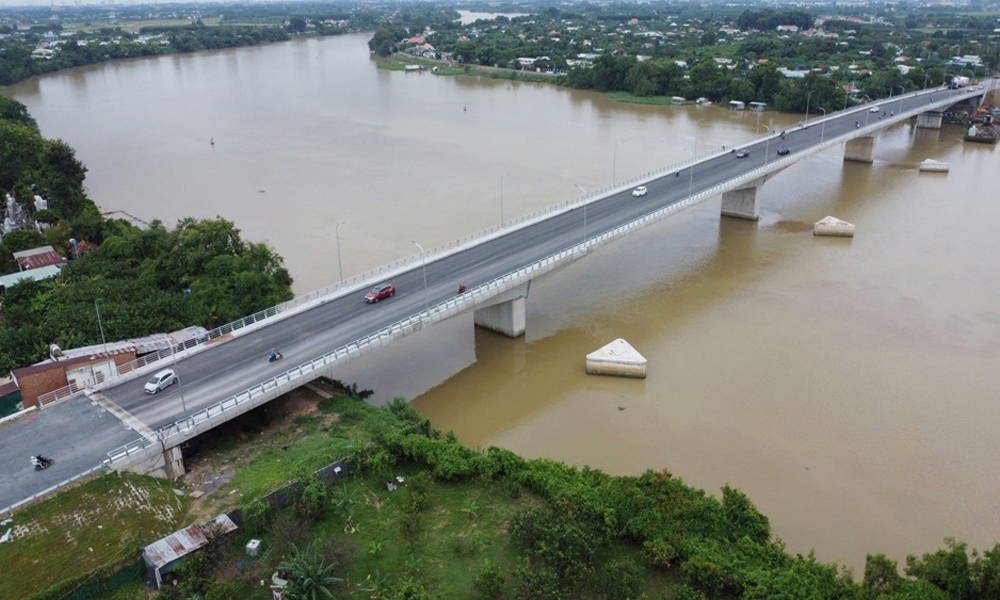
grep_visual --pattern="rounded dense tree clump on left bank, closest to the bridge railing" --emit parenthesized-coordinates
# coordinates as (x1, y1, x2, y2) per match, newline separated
(0, 219, 291, 370)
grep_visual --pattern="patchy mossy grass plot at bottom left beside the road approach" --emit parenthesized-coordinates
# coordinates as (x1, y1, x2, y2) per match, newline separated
(0, 473, 187, 598)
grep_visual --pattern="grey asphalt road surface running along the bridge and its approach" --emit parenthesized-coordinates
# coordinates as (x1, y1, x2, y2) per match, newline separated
(0, 89, 976, 507)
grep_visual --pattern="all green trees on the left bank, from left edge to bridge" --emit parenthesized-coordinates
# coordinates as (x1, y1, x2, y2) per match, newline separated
(0, 98, 292, 372)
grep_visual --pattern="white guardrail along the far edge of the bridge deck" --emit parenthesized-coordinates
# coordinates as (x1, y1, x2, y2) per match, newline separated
(45, 89, 985, 408)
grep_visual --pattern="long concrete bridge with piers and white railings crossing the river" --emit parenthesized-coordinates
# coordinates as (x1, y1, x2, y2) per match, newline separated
(0, 83, 986, 505)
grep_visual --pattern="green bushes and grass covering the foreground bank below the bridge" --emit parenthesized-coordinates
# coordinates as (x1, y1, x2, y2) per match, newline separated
(0, 389, 1000, 600)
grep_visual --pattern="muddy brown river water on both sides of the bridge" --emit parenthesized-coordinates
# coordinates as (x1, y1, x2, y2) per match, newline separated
(5, 36, 1000, 572)
